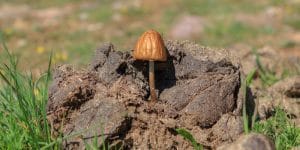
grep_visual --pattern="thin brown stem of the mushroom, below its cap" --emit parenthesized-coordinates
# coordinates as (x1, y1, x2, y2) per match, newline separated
(149, 60, 157, 102)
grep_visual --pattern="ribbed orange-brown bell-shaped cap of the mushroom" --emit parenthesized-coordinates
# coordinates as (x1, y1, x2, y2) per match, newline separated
(133, 30, 167, 61)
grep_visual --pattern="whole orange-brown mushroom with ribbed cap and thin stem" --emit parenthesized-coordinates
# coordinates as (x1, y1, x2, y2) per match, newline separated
(133, 30, 167, 102)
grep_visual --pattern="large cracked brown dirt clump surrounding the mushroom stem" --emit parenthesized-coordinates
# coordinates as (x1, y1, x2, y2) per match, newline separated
(47, 41, 247, 149)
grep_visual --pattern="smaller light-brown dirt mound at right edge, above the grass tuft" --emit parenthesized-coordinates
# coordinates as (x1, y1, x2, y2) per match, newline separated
(257, 76, 300, 124)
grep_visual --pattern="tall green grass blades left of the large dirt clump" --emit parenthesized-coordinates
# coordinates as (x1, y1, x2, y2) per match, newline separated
(0, 44, 54, 149)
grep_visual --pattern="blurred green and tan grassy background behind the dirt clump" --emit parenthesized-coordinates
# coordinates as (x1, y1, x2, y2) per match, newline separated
(0, 0, 300, 73)
